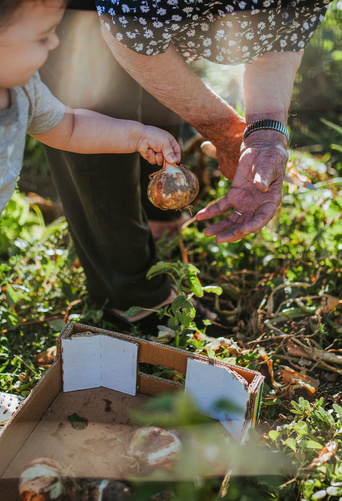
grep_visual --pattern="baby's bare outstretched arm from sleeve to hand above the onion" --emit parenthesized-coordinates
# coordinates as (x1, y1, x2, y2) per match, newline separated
(33, 106, 181, 165)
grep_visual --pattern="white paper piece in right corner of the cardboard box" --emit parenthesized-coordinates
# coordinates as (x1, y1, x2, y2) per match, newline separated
(185, 358, 249, 440)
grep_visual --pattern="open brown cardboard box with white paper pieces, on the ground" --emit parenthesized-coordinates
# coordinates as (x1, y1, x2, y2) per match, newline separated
(0, 324, 264, 501)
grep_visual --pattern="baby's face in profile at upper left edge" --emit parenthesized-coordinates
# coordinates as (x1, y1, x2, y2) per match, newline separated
(0, 0, 64, 89)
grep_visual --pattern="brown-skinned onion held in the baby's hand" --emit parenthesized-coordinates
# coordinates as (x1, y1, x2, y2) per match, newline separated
(147, 162, 199, 210)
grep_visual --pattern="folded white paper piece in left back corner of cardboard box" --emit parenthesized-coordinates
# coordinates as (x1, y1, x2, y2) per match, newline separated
(62, 335, 138, 395)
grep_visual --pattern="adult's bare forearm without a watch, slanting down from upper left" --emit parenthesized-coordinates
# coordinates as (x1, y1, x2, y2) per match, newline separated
(102, 28, 246, 179)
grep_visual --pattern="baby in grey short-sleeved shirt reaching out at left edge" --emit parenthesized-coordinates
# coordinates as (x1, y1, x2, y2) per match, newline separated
(0, 0, 180, 213)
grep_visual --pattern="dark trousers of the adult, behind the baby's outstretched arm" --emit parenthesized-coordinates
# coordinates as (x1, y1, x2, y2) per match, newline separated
(40, 10, 181, 309)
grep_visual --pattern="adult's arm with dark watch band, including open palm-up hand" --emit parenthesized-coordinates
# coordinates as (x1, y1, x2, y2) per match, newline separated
(197, 52, 303, 243)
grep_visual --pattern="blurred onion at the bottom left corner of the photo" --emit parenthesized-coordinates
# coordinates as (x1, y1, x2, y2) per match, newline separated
(19, 458, 63, 501)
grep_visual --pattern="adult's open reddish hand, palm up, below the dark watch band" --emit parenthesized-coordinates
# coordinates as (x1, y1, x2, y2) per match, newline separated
(196, 131, 288, 243)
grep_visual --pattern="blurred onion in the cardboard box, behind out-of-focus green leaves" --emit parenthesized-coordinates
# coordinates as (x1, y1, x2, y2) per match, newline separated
(126, 426, 181, 474)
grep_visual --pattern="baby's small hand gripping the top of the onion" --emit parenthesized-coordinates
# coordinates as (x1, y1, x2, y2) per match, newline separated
(137, 125, 181, 167)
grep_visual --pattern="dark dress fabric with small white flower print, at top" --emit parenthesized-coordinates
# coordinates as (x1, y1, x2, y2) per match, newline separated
(96, 0, 330, 64)
